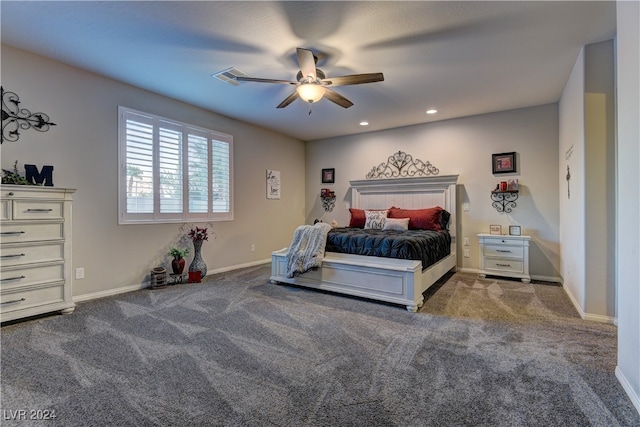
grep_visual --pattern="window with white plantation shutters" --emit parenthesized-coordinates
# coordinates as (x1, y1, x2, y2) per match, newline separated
(118, 107, 233, 224)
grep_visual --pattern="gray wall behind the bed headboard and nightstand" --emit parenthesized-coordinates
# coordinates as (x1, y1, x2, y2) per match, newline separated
(306, 104, 560, 280)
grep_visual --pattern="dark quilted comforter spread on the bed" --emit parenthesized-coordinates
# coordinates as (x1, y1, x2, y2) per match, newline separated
(326, 227, 451, 269)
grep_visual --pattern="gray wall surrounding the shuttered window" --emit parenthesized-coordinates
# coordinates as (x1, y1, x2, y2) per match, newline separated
(1, 45, 305, 298)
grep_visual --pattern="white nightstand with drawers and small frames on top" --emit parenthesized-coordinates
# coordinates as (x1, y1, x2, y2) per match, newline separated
(478, 234, 531, 283)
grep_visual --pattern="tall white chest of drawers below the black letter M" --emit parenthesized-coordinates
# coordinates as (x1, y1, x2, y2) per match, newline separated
(0, 185, 75, 322)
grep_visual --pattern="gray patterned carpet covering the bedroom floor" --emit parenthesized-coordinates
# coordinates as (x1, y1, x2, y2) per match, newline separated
(1, 266, 640, 426)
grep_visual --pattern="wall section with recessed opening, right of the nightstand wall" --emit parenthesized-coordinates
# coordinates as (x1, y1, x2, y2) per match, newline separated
(558, 40, 616, 323)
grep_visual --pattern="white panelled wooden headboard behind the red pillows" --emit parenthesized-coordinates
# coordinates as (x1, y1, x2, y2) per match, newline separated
(350, 175, 458, 242)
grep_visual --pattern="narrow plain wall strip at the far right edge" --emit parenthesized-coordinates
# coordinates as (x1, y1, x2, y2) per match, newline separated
(616, 1, 640, 412)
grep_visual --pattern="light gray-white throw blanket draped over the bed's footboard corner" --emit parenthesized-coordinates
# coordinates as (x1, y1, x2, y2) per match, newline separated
(286, 222, 331, 277)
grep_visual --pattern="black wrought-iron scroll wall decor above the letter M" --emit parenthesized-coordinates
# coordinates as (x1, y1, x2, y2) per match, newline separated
(0, 86, 56, 144)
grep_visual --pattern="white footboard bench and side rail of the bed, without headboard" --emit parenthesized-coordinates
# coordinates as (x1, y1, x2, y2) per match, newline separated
(271, 248, 456, 312)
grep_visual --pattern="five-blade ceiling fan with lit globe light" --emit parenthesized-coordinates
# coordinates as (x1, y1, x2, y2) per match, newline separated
(236, 47, 384, 110)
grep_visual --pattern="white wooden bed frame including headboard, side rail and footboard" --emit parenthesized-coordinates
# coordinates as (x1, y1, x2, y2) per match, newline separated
(271, 175, 458, 312)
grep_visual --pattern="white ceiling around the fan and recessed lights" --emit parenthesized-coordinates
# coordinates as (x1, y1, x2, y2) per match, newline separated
(0, 1, 615, 141)
